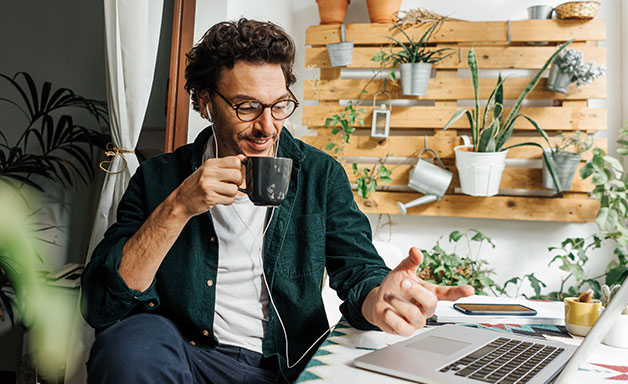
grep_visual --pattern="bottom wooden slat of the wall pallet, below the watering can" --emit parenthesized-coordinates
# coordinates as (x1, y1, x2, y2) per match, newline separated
(354, 192, 600, 223)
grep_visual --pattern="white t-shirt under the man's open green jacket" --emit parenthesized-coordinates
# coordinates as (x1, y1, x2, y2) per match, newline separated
(204, 139, 268, 353)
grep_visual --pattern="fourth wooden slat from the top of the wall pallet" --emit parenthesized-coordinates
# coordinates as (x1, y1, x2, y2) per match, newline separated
(302, 105, 606, 131)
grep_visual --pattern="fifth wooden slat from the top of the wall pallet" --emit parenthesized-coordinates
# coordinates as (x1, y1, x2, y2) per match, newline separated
(301, 135, 607, 160)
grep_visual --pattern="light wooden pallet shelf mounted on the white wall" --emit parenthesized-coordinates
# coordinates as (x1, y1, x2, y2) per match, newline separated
(303, 19, 607, 222)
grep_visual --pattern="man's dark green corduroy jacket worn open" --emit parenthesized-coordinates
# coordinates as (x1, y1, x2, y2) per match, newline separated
(82, 129, 389, 380)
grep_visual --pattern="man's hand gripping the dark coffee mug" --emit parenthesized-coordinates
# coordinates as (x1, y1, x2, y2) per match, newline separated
(176, 155, 246, 217)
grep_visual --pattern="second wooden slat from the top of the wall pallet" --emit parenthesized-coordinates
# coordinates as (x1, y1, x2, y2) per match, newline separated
(305, 46, 606, 69)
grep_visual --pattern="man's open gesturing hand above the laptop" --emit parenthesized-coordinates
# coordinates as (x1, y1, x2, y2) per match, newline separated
(362, 247, 473, 336)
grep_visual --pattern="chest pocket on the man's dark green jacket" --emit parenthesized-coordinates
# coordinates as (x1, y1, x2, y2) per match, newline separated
(276, 213, 325, 279)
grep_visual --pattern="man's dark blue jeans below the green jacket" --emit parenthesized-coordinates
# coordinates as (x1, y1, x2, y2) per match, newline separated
(87, 314, 280, 384)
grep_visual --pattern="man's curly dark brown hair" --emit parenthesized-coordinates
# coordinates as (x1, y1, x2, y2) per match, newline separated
(185, 18, 296, 111)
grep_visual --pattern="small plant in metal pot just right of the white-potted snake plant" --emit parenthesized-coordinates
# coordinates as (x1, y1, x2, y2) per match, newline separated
(542, 131, 593, 191)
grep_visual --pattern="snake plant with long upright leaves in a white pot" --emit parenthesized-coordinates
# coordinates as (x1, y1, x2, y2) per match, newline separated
(443, 40, 573, 196)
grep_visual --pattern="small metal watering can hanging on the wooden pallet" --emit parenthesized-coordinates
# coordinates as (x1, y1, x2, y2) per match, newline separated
(397, 141, 454, 215)
